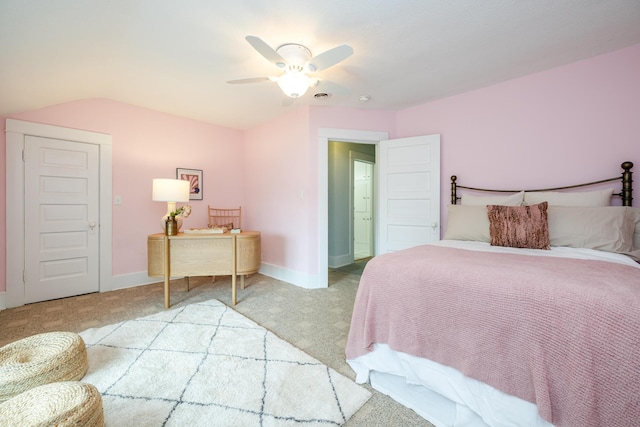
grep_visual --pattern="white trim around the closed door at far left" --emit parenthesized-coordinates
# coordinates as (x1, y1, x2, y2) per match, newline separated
(5, 119, 113, 308)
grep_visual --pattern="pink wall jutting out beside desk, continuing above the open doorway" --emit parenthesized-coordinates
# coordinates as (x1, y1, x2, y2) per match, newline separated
(244, 107, 395, 276)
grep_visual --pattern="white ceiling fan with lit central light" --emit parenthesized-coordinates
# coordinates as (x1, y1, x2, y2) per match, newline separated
(227, 36, 353, 98)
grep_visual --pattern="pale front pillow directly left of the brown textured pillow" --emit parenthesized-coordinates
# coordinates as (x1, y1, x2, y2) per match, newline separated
(443, 205, 491, 243)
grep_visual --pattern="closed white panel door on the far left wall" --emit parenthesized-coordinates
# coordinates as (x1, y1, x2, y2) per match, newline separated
(24, 136, 100, 303)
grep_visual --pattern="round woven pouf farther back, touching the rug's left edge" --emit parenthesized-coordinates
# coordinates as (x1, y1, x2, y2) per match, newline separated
(0, 332, 89, 402)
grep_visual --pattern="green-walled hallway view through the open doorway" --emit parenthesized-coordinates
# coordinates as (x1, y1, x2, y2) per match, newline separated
(328, 141, 376, 271)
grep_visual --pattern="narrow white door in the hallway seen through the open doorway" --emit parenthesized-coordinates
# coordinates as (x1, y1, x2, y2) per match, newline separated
(353, 160, 373, 260)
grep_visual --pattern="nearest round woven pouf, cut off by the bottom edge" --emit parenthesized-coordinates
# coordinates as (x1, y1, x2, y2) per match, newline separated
(0, 381, 104, 427)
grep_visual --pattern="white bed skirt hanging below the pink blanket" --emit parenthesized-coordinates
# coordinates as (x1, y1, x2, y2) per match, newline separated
(347, 344, 553, 427)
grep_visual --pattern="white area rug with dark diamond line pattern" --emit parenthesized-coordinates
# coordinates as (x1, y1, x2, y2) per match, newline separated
(80, 300, 371, 427)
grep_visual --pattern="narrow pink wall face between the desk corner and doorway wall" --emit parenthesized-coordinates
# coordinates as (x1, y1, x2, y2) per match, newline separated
(244, 108, 311, 272)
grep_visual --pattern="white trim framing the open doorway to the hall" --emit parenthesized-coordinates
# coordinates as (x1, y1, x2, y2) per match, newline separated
(318, 128, 389, 288)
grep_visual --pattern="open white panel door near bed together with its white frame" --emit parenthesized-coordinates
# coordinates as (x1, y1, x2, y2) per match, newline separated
(318, 128, 440, 288)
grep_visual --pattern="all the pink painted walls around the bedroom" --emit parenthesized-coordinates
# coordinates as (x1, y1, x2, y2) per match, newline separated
(0, 45, 640, 298)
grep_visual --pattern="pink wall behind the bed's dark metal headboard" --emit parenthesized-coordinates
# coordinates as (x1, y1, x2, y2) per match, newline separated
(396, 45, 640, 224)
